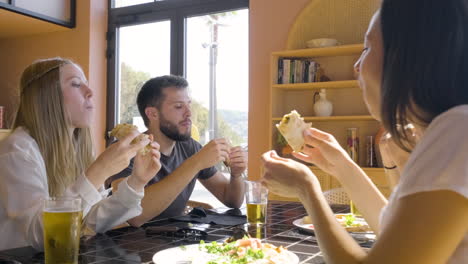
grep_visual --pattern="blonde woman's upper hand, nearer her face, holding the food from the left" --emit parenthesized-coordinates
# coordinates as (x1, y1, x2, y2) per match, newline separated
(86, 129, 150, 188)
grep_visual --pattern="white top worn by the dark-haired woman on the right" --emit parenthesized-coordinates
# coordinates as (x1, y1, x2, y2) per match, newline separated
(380, 105, 468, 264)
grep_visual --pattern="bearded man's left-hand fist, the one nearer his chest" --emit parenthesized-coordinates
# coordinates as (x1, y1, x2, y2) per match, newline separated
(192, 138, 229, 170)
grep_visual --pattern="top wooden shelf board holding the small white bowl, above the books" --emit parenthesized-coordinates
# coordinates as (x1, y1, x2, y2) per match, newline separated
(272, 44, 364, 57)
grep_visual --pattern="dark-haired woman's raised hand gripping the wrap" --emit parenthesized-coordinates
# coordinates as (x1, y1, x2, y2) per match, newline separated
(293, 128, 354, 177)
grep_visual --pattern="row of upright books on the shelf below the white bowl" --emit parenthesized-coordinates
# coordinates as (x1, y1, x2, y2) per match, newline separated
(277, 58, 323, 84)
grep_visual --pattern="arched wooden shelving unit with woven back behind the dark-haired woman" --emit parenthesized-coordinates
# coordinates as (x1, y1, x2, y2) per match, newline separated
(265, 3, 390, 201)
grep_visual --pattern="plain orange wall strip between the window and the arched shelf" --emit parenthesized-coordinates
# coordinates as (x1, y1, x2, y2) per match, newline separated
(249, 0, 310, 179)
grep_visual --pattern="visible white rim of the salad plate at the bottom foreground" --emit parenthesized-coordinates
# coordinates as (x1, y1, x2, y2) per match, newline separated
(153, 244, 299, 264)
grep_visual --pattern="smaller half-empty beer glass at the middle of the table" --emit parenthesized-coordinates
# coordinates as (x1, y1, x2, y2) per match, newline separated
(245, 181, 268, 224)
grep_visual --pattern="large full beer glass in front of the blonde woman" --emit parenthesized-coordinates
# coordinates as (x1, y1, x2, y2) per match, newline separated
(42, 197, 83, 264)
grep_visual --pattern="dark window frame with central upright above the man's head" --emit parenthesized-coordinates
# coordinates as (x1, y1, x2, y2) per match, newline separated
(105, 0, 249, 144)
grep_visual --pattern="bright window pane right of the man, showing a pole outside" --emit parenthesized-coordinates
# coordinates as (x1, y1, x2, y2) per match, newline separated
(186, 9, 248, 145)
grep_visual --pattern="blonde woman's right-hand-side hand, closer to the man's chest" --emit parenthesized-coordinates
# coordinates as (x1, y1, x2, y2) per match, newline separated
(128, 135, 161, 191)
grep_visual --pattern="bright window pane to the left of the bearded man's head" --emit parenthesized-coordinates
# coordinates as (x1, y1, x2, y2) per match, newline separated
(117, 21, 171, 131)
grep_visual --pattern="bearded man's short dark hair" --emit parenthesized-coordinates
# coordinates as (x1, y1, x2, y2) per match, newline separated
(137, 75, 188, 127)
